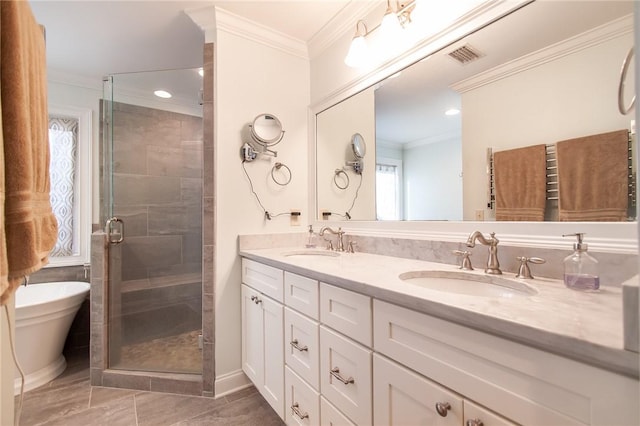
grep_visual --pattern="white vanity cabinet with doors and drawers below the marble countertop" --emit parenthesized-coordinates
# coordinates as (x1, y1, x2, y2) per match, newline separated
(242, 259, 640, 426)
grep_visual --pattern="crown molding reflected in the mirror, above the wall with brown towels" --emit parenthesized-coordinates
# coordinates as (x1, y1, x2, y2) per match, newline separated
(450, 15, 633, 93)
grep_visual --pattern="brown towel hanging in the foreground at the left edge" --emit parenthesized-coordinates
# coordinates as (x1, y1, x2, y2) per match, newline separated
(0, 0, 57, 304)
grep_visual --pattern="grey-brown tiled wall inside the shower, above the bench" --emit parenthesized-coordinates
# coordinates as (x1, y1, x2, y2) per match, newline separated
(113, 103, 202, 284)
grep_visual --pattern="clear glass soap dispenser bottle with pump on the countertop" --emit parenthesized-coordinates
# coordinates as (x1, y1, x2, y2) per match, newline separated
(563, 233, 600, 291)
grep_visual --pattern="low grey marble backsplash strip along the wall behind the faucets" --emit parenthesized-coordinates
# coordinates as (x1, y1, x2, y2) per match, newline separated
(239, 233, 638, 287)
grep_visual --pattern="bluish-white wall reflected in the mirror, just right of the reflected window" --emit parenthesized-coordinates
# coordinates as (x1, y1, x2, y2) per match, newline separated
(403, 140, 462, 220)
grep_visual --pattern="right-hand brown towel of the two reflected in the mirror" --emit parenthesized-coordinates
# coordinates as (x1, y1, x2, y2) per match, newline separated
(556, 130, 629, 221)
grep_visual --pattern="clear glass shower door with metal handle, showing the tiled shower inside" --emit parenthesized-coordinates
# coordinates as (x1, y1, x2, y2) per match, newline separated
(101, 69, 203, 374)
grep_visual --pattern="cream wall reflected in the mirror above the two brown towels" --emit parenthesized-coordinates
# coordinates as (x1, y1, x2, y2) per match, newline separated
(462, 34, 633, 220)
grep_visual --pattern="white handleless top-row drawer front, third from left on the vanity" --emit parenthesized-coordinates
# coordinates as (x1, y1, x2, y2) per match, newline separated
(320, 283, 371, 347)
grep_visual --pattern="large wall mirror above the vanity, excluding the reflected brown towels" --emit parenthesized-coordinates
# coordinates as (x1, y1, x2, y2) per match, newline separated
(316, 1, 635, 221)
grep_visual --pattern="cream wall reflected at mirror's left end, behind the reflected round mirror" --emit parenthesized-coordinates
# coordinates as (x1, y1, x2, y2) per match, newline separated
(316, 88, 376, 220)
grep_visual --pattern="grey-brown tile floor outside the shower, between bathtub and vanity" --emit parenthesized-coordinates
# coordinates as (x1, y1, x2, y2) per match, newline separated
(16, 357, 284, 426)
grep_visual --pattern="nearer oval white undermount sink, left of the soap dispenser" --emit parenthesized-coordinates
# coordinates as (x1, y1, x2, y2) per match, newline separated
(399, 271, 538, 298)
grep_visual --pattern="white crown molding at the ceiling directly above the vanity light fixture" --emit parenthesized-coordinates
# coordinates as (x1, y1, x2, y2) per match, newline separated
(308, 0, 386, 59)
